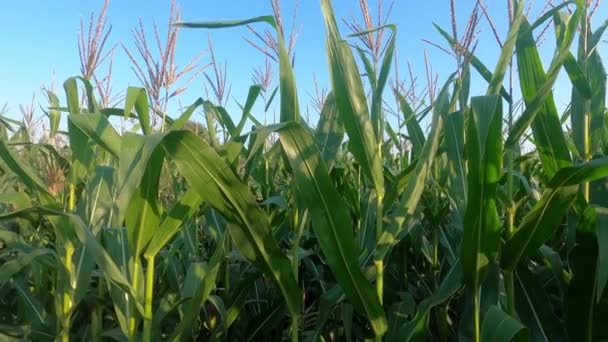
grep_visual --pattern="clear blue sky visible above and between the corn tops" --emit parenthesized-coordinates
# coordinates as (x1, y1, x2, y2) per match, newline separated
(0, 0, 608, 127)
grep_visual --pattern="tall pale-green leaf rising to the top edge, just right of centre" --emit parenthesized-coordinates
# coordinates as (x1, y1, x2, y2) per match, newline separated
(321, 0, 384, 198)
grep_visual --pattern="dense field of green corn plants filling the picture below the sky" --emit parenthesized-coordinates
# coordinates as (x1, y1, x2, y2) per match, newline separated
(0, 0, 608, 342)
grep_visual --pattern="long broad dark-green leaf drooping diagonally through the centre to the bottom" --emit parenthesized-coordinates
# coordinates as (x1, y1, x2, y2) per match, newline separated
(279, 124, 387, 336)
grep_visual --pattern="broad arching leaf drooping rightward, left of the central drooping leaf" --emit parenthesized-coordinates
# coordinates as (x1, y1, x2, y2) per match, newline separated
(163, 131, 301, 314)
